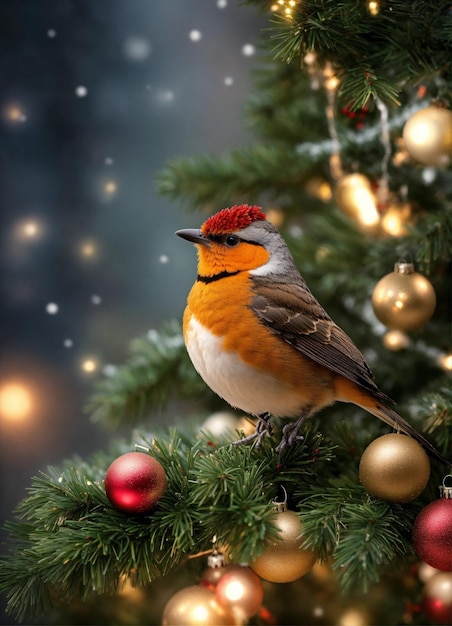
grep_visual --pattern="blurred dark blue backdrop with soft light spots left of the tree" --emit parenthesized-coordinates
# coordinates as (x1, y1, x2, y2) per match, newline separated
(0, 0, 264, 604)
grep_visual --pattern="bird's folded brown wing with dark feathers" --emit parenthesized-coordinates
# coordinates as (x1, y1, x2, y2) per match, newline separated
(251, 276, 391, 402)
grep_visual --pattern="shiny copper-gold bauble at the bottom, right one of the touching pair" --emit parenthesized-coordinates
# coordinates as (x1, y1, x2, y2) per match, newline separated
(215, 565, 264, 622)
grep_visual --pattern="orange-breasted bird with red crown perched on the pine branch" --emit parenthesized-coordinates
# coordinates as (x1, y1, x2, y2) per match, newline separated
(176, 204, 450, 464)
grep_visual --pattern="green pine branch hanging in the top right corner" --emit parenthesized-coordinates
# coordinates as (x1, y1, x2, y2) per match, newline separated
(264, 0, 451, 108)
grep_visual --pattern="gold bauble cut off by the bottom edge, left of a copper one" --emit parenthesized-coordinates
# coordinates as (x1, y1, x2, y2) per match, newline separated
(162, 585, 236, 626)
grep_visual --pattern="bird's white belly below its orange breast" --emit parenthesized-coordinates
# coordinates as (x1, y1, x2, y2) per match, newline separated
(185, 316, 301, 416)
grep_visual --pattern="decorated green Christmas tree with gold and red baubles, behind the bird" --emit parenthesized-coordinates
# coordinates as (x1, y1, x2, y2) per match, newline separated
(0, 0, 452, 625)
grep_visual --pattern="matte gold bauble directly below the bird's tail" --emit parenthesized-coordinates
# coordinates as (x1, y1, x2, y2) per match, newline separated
(359, 433, 430, 503)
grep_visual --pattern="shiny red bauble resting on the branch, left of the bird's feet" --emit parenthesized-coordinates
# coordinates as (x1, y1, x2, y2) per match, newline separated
(105, 452, 167, 515)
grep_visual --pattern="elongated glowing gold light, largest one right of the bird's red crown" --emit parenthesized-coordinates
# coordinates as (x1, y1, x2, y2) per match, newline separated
(336, 174, 380, 230)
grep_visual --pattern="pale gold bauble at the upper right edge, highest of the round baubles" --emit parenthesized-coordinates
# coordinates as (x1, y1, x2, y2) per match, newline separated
(403, 104, 452, 167)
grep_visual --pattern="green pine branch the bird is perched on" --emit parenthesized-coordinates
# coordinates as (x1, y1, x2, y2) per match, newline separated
(0, 414, 444, 619)
